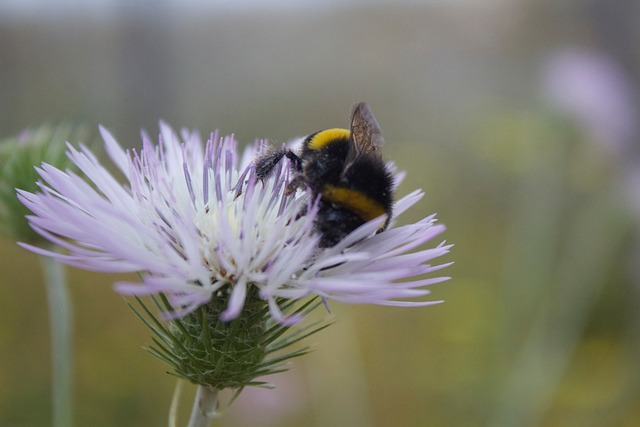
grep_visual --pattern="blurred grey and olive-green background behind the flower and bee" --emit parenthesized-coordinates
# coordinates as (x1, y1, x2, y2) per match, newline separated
(0, 0, 640, 427)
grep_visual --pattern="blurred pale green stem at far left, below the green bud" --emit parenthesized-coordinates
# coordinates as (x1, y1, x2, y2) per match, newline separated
(41, 257, 72, 427)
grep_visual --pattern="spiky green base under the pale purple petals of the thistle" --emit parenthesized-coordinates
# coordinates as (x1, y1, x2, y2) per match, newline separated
(130, 288, 328, 390)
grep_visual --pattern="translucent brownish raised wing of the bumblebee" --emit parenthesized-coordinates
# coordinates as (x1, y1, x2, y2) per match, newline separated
(344, 102, 384, 171)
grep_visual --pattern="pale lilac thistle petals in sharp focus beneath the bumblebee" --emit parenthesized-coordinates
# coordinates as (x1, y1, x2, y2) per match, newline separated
(19, 124, 450, 322)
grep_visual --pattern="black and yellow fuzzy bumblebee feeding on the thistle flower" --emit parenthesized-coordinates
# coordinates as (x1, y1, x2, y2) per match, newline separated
(254, 102, 394, 248)
